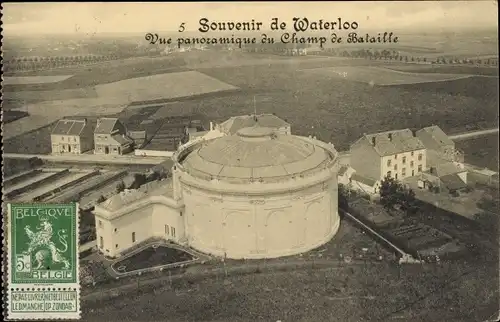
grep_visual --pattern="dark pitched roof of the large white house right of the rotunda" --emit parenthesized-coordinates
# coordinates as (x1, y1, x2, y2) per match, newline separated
(357, 129, 425, 156)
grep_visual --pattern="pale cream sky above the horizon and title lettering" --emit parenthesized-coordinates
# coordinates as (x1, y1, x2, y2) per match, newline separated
(2, 0, 498, 37)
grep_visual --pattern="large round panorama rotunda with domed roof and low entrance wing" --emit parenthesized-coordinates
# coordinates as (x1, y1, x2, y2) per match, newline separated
(94, 126, 340, 259)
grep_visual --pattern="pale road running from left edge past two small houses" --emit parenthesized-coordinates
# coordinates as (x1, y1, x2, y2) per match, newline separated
(3, 153, 167, 165)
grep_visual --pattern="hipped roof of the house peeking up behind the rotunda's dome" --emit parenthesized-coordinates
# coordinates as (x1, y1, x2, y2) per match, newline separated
(220, 114, 290, 134)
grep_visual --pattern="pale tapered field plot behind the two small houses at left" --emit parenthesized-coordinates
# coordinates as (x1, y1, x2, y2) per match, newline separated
(95, 71, 237, 102)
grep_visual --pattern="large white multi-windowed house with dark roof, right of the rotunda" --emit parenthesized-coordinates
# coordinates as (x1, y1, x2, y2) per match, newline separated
(350, 129, 427, 181)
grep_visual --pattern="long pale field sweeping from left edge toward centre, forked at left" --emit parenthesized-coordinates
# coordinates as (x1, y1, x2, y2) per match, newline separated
(4, 71, 237, 139)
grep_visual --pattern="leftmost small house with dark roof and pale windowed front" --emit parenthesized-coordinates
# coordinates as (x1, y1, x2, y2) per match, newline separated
(50, 119, 94, 154)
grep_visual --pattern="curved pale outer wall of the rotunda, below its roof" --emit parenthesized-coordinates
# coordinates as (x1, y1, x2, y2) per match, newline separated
(181, 175, 340, 259)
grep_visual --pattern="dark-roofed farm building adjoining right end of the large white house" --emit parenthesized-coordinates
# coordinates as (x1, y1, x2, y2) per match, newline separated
(417, 125, 464, 167)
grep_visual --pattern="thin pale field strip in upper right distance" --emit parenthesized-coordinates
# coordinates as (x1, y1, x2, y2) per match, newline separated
(304, 66, 469, 86)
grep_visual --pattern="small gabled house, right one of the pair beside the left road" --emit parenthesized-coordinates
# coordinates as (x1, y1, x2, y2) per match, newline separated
(94, 118, 133, 154)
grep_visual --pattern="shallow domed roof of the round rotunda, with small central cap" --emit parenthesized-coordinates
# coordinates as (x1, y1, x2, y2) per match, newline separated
(178, 126, 332, 181)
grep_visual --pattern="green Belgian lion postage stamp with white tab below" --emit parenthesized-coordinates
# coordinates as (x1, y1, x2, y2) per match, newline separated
(4, 203, 80, 320)
